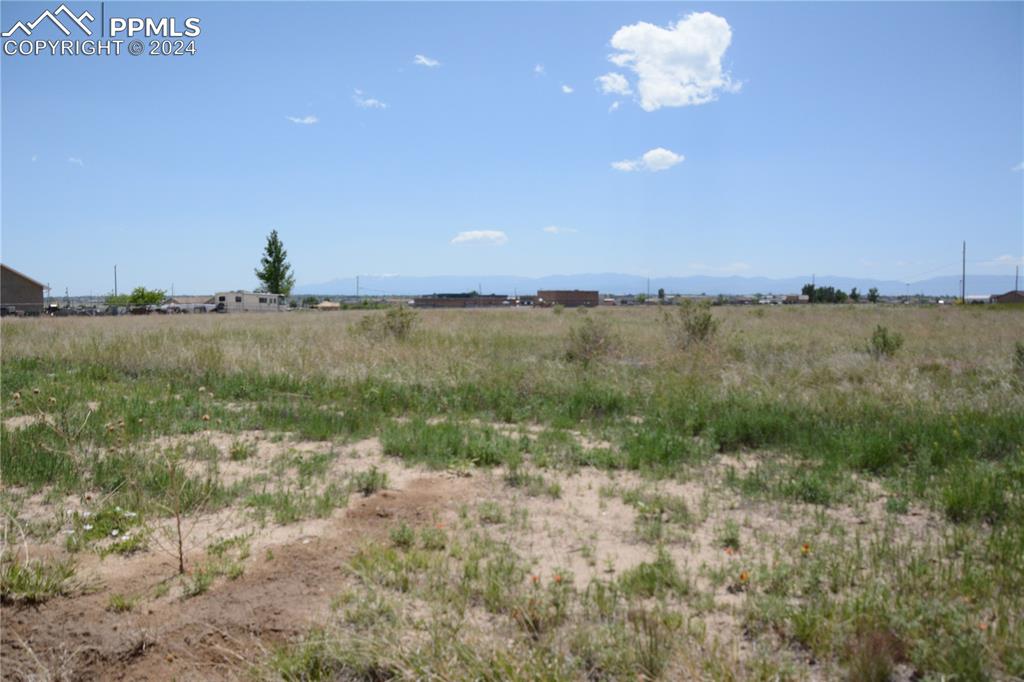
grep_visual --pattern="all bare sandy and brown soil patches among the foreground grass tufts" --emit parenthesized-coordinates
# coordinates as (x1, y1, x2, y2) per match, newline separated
(0, 421, 939, 680)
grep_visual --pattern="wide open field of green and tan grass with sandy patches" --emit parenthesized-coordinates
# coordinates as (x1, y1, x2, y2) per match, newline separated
(0, 305, 1024, 680)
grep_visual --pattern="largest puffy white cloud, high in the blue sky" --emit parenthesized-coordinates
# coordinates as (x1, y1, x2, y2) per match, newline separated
(598, 12, 740, 112)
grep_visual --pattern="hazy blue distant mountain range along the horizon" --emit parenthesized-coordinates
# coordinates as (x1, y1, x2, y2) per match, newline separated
(294, 272, 1014, 296)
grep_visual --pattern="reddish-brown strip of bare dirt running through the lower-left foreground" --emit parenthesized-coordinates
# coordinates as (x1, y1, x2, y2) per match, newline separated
(0, 475, 471, 680)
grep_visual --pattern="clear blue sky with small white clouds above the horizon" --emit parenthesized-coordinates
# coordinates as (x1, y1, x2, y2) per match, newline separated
(0, 2, 1024, 295)
